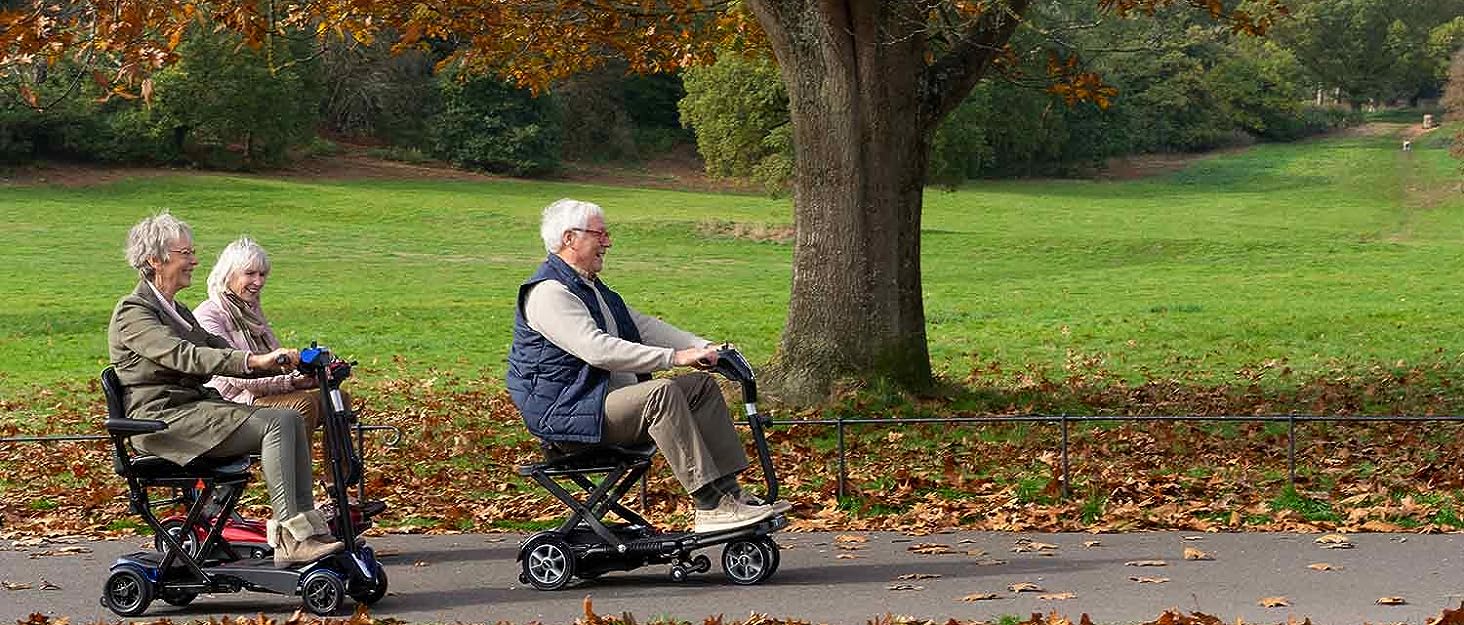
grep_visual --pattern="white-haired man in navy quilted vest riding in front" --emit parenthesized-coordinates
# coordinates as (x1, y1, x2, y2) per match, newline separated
(508, 199, 788, 533)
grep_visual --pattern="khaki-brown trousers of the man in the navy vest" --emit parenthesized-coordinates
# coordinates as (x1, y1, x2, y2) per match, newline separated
(600, 372, 747, 493)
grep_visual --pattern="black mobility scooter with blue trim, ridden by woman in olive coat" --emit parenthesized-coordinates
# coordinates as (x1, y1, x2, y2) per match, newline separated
(101, 344, 386, 616)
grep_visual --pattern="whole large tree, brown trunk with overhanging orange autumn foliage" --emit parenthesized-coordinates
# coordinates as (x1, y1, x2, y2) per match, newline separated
(0, 0, 1284, 401)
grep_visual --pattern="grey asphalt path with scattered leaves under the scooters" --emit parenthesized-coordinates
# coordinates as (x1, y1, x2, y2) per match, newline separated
(0, 531, 1464, 625)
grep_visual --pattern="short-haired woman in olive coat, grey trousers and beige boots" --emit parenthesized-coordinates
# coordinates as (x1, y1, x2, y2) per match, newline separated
(107, 211, 344, 566)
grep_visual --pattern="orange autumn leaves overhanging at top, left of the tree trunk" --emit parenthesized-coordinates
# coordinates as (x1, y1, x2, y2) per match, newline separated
(0, 0, 766, 95)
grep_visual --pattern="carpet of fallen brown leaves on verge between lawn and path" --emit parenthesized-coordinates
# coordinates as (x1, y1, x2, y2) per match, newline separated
(0, 352, 1464, 544)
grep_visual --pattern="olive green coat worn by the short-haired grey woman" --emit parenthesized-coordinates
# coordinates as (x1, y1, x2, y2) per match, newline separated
(107, 282, 259, 464)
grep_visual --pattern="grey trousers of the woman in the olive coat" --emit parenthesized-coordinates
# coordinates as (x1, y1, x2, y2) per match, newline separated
(203, 408, 315, 521)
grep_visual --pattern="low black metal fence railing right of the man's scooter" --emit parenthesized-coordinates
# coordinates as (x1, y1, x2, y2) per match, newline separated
(770, 414, 1464, 501)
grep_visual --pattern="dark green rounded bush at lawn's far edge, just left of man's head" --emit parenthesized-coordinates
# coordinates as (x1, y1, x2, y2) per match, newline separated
(427, 70, 561, 176)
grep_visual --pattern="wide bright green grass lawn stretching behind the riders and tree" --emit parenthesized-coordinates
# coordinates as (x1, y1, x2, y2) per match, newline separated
(0, 124, 1464, 397)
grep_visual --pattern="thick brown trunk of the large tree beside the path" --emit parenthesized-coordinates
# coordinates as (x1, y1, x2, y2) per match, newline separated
(752, 0, 931, 403)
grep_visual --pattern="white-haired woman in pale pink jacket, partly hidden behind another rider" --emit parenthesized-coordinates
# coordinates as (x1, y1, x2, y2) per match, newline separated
(193, 237, 385, 517)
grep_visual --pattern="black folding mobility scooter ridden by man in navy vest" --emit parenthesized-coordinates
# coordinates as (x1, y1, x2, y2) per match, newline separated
(518, 347, 788, 590)
